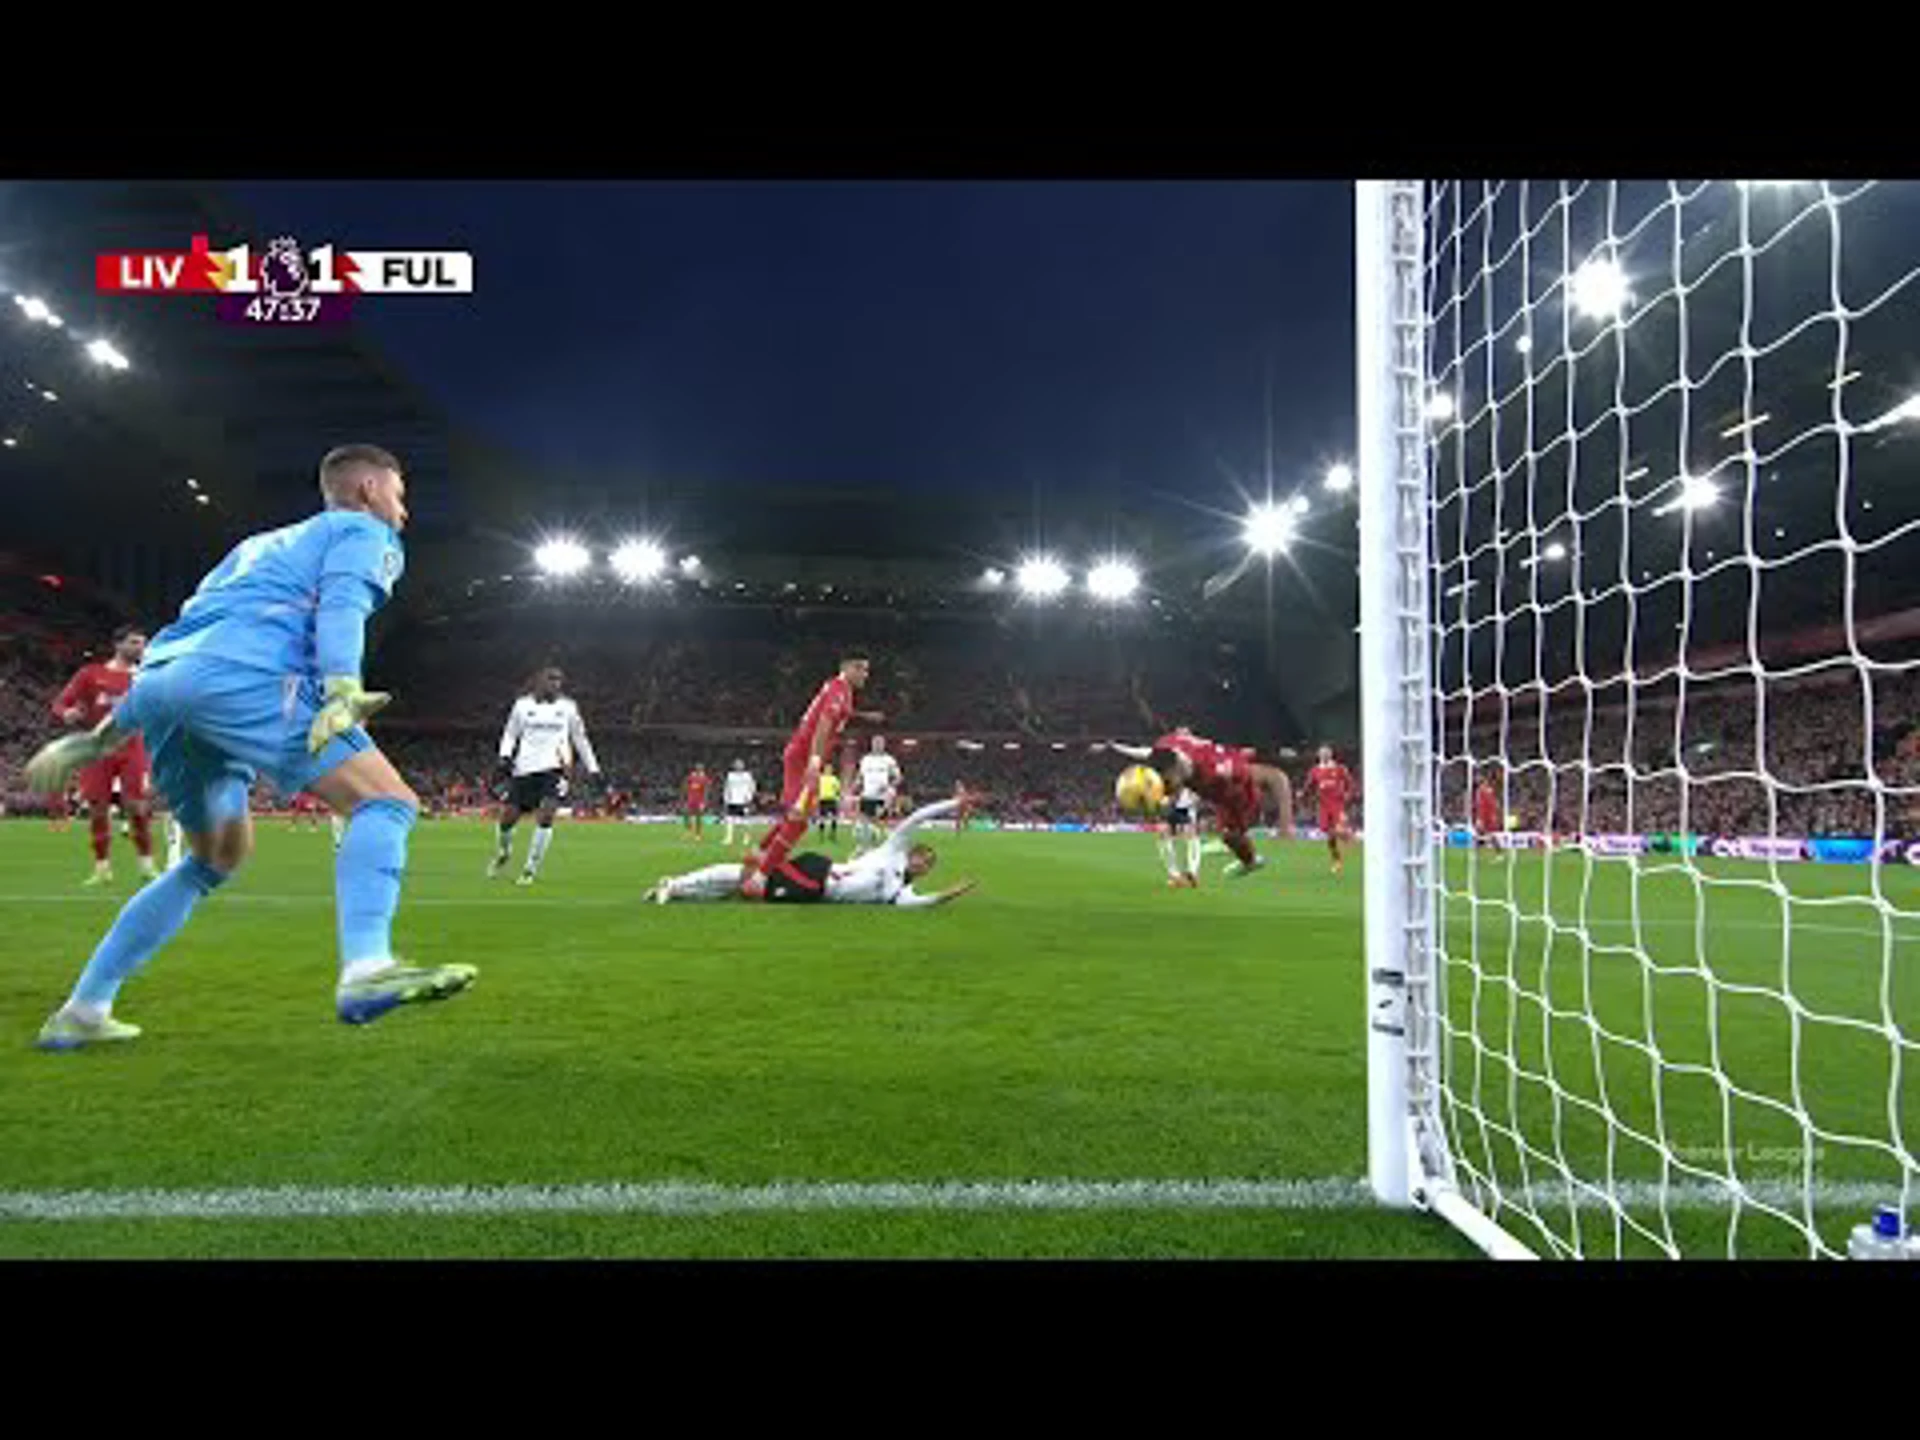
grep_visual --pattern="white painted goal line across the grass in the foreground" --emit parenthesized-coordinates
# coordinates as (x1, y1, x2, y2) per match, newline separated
(0, 1179, 1897, 1223)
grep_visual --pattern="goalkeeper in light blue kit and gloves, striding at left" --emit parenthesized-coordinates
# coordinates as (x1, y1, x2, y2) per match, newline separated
(27, 445, 476, 1050)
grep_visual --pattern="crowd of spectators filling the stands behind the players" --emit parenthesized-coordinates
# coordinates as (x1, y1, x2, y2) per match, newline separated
(15, 570, 1920, 837)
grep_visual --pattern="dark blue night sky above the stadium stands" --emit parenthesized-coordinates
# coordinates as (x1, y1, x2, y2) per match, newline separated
(228, 182, 1354, 503)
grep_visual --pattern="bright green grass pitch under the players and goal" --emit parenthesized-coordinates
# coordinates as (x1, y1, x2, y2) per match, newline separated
(0, 822, 1920, 1258)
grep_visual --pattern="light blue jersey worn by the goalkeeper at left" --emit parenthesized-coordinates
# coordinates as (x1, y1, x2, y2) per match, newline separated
(144, 511, 407, 678)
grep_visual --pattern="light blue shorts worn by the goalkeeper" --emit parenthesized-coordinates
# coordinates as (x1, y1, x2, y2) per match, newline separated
(113, 655, 374, 833)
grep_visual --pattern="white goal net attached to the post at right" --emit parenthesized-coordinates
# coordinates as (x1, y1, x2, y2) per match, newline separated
(1359, 180, 1920, 1258)
